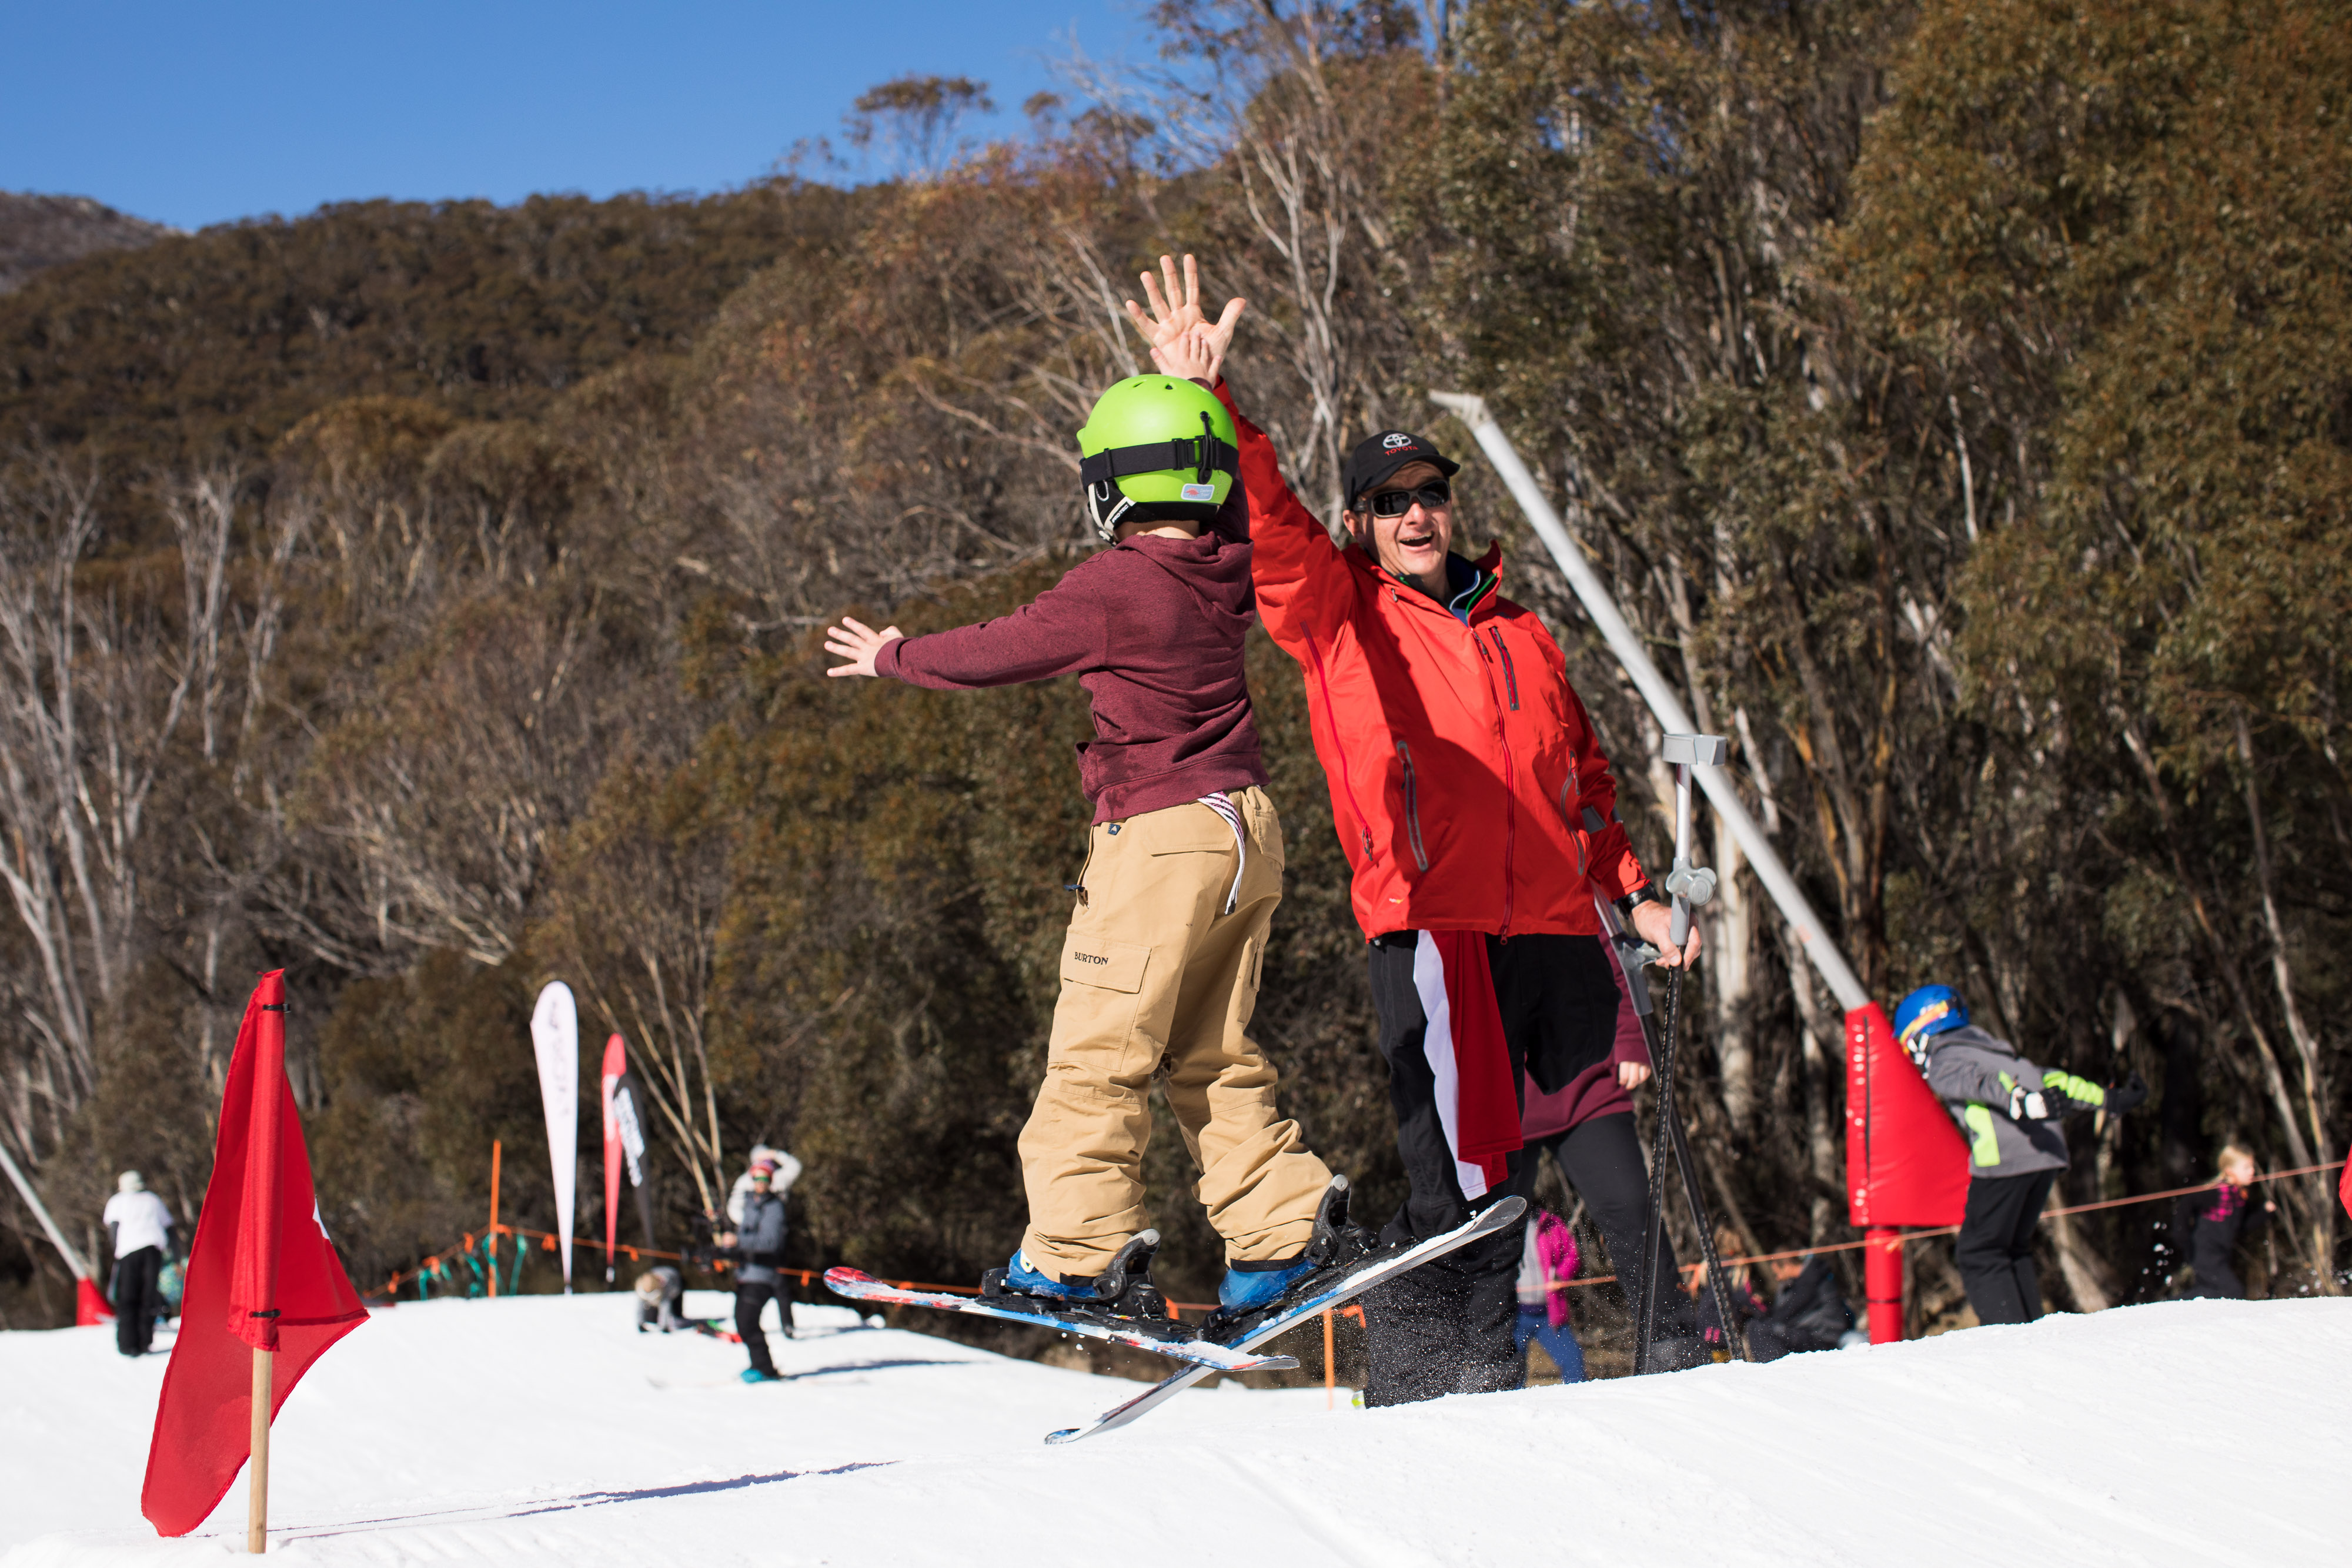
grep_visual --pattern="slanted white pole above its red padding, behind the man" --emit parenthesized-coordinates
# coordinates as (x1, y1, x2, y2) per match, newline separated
(1430, 393, 1870, 1013)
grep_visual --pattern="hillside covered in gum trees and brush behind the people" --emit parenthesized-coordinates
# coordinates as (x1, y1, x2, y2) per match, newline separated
(0, 0, 2352, 1326)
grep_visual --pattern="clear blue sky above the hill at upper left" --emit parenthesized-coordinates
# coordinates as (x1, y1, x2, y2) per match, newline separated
(0, 0, 1152, 228)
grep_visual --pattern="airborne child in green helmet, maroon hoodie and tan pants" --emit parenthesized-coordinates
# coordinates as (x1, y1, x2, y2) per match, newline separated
(826, 324, 1345, 1312)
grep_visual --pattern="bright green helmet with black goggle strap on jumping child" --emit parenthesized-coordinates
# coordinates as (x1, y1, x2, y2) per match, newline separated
(1077, 376, 1242, 543)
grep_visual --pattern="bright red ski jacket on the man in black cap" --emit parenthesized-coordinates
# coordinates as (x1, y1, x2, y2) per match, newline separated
(1216, 386, 1649, 935)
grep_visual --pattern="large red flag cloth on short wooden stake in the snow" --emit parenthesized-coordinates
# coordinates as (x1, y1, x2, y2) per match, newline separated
(139, 968, 367, 1535)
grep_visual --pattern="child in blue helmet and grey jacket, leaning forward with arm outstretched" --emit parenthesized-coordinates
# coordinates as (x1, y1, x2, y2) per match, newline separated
(1896, 985, 2147, 1323)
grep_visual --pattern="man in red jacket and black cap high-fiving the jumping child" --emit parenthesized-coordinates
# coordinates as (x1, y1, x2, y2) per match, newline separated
(1129, 259, 1698, 1403)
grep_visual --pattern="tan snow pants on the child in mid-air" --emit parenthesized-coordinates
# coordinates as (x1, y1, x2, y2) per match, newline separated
(1021, 787, 1331, 1279)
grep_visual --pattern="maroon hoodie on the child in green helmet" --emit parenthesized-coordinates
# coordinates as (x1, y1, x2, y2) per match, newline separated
(875, 505, 1265, 823)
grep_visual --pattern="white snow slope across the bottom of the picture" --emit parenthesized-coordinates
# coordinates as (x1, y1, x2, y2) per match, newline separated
(0, 1295, 2352, 1568)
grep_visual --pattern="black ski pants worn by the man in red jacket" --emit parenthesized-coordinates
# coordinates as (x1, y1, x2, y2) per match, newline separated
(1364, 931, 1639, 1406)
